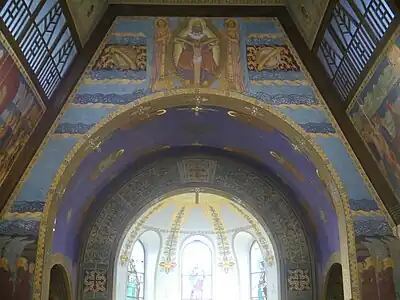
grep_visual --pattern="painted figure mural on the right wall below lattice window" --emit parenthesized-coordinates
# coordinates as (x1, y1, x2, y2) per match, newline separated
(348, 27, 400, 202)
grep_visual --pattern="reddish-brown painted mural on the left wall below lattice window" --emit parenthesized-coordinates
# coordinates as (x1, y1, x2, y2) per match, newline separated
(0, 33, 45, 185)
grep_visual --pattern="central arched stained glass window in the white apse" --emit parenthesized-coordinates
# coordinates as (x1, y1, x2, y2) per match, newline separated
(182, 241, 212, 300)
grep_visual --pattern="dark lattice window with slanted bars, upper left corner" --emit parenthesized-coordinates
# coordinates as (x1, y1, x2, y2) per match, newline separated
(0, 0, 77, 97)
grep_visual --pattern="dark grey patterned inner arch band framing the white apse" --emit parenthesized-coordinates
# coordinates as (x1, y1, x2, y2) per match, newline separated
(76, 156, 316, 299)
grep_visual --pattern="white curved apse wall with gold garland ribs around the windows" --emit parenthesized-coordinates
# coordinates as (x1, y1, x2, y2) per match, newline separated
(113, 193, 280, 300)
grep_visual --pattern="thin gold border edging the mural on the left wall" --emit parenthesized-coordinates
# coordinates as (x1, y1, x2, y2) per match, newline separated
(0, 31, 47, 188)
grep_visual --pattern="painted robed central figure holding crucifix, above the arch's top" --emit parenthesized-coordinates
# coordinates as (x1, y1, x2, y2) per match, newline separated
(175, 18, 218, 86)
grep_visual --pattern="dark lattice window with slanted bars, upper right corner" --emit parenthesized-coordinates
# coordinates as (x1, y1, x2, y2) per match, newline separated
(318, 0, 394, 101)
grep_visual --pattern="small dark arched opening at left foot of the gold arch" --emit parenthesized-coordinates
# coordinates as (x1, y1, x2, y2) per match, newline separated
(49, 264, 72, 300)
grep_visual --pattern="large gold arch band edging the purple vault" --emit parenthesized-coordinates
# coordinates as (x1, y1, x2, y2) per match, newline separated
(34, 89, 359, 298)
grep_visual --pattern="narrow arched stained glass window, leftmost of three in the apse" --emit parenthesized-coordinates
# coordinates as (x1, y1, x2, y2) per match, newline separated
(126, 240, 145, 300)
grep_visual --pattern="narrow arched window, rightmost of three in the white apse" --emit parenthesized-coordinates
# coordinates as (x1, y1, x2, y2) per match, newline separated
(250, 241, 267, 300)
